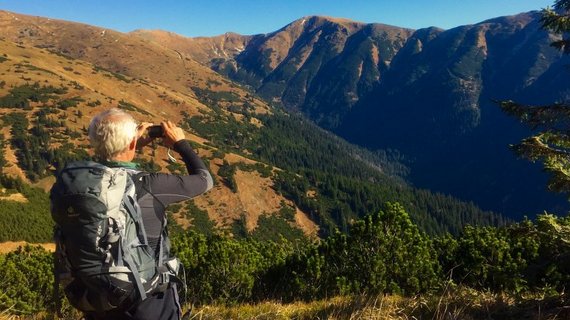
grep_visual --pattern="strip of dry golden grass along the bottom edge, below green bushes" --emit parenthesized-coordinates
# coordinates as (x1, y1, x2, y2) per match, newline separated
(186, 288, 570, 320)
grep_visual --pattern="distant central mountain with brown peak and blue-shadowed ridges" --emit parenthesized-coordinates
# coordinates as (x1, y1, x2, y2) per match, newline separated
(133, 16, 413, 122)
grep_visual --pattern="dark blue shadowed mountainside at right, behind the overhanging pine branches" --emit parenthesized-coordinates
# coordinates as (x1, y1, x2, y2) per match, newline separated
(336, 13, 570, 217)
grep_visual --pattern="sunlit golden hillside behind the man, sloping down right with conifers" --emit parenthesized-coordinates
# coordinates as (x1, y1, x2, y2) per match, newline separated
(0, 11, 507, 242)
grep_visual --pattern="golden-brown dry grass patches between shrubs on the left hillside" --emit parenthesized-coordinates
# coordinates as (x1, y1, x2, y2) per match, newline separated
(0, 27, 306, 235)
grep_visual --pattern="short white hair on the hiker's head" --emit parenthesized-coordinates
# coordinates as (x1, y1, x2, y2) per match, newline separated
(89, 108, 137, 160)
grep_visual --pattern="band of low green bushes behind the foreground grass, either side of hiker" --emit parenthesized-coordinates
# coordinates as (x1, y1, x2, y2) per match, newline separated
(0, 203, 570, 314)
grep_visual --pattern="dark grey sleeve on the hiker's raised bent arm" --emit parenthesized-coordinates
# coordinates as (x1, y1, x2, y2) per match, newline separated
(148, 140, 214, 206)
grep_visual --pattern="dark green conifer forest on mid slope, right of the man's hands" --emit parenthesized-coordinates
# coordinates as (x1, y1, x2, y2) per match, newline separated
(185, 105, 508, 236)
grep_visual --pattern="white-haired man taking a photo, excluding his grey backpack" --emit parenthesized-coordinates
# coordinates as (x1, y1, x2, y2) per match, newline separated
(87, 109, 213, 320)
